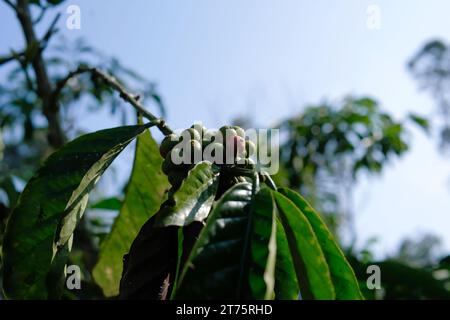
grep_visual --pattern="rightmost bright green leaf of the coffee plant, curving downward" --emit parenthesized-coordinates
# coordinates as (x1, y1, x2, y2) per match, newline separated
(278, 188, 363, 300)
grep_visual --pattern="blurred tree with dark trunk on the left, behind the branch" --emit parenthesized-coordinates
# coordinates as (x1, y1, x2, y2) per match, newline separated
(0, 0, 164, 297)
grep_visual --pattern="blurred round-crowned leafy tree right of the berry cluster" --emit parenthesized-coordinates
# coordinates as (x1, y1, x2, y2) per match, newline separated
(276, 97, 428, 243)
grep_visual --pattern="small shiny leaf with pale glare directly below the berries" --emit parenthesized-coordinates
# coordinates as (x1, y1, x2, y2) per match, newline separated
(155, 162, 219, 227)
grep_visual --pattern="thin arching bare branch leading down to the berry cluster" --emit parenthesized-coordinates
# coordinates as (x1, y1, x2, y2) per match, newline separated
(52, 66, 173, 135)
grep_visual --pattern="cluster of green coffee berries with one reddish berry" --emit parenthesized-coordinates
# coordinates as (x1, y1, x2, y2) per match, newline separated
(159, 124, 256, 188)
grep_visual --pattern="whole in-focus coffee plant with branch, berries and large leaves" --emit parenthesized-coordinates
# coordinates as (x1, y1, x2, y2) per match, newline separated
(2, 66, 362, 299)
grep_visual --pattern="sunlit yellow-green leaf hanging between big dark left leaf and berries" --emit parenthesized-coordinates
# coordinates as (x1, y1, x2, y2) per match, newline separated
(93, 131, 169, 297)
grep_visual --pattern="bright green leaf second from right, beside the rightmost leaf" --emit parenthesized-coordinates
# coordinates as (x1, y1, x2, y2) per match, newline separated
(274, 192, 335, 299)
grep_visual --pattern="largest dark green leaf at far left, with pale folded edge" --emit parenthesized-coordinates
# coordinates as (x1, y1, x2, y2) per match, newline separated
(3, 125, 147, 299)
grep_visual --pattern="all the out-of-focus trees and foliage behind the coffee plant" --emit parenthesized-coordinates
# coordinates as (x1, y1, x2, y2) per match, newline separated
(0, 0, 450, 299)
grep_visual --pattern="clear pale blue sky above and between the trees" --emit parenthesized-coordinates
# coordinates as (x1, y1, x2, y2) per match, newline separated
(0, 0, 450, 255)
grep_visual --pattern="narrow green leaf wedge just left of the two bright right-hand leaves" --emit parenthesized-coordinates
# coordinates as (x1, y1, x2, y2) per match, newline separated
(275, 219, 300, 300)
